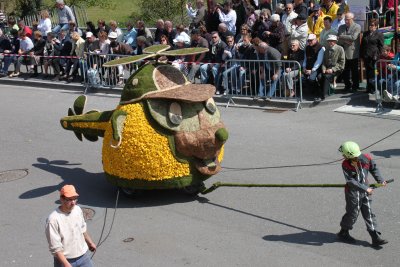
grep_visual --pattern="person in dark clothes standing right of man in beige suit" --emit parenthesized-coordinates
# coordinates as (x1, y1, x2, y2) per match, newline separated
(360, 19, 384, 93)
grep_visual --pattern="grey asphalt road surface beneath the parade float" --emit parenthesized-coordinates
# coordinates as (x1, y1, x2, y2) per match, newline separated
(0, 85, 400, 267)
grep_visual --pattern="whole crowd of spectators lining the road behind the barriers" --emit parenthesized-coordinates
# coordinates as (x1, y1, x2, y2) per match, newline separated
(0, 0, 400, 101)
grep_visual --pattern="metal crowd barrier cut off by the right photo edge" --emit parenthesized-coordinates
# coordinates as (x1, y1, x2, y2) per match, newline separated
(375, 59, 400, 112)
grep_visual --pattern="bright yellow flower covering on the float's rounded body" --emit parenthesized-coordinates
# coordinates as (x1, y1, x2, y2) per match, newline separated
(103, 103, 191, 181)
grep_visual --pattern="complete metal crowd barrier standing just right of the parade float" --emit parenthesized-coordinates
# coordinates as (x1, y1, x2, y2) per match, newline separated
(221, 60, 303, 111)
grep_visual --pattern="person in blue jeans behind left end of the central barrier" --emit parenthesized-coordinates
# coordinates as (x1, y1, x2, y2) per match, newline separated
(221, 36, 241, 95)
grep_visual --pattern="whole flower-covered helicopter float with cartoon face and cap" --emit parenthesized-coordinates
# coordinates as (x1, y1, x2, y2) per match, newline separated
(61, 45, 228, 195)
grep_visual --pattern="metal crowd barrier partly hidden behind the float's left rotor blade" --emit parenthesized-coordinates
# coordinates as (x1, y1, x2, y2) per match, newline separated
(81, 53, 141, 92)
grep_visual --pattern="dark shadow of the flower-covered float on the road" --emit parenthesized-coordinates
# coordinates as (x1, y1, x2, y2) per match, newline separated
(19, 158, 204, 208)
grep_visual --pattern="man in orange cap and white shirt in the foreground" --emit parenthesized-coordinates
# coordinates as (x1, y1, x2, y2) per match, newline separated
(46, 185, 96, 267)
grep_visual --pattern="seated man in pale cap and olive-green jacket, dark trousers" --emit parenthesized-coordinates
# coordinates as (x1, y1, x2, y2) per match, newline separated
(315, 35, 346, 101)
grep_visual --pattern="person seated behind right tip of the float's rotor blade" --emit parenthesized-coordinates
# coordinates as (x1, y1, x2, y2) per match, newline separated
(186, 29, 208, 83)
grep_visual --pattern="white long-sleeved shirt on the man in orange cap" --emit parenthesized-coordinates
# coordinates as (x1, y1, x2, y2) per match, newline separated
(46, 206, 89, 259)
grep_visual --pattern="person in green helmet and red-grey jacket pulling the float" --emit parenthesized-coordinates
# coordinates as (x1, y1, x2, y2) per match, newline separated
(337, 141, 388, 246)
